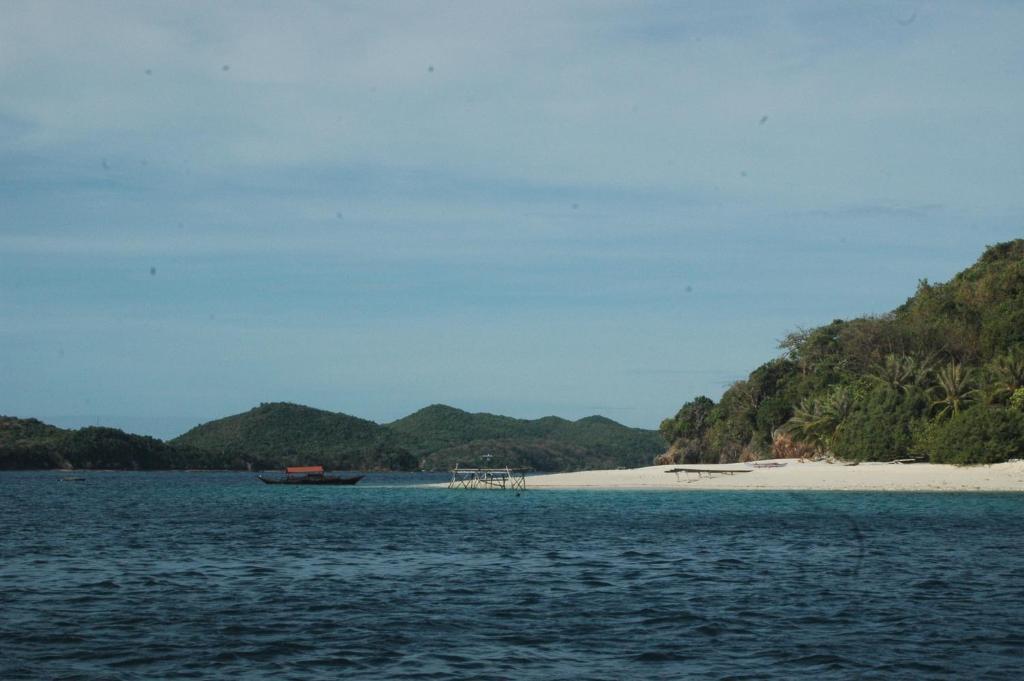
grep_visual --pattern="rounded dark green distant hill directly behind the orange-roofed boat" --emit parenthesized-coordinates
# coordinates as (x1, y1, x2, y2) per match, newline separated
(170, 402, 419, 470)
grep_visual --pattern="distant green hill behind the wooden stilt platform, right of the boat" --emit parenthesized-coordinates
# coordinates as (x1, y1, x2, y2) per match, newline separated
(386, 405, 667, 471)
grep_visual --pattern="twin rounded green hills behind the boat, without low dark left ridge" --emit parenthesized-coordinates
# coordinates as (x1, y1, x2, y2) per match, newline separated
(170, 402, 667, 470)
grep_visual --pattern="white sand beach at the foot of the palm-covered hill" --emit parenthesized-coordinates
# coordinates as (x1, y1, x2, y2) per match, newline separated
(526, 459, 1024, 492)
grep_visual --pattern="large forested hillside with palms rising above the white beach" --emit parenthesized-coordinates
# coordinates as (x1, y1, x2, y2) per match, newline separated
(659, 240, 1024, 463)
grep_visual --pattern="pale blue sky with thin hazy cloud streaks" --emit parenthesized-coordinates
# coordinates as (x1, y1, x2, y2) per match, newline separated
(0, 0, 1024, 437)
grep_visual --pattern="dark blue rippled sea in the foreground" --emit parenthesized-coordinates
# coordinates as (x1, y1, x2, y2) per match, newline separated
(0, 471, 1024, 681)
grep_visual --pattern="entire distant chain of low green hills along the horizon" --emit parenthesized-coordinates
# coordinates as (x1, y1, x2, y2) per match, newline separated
(0, 402, 668, 472)
